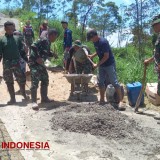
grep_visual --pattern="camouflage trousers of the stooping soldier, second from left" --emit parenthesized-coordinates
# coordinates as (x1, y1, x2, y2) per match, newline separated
(30, 64, 49, 90)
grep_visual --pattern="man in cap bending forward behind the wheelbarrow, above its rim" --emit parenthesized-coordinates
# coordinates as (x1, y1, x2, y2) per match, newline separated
(67, 40, 92, 74)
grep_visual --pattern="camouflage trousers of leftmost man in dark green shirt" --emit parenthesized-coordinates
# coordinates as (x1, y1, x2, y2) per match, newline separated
(3, 60, 26, 84)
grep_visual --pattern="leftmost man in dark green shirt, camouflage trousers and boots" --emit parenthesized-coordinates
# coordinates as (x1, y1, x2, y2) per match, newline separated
(0, 21, 28, 105)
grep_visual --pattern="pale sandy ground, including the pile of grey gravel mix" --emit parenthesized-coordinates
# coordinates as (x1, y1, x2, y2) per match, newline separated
(0, 16, 160, 160)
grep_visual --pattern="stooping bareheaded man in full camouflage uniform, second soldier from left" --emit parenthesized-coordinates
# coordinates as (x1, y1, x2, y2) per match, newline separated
(29, 29, 57, 110)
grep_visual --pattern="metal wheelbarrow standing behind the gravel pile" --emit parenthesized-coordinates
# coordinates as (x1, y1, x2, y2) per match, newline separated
(64, 74, 93, 100)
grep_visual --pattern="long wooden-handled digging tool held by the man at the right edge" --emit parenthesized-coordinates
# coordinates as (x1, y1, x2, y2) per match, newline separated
(135, 65, 147, 114)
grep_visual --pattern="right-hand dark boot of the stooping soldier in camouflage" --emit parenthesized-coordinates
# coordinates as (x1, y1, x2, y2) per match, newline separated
(41, 85, 53, 103)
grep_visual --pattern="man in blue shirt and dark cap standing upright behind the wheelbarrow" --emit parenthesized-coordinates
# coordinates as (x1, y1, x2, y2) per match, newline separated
(61, 21, 72, 72)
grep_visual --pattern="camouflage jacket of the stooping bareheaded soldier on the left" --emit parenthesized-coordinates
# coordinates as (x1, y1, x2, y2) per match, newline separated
(28, 38, 53, 66)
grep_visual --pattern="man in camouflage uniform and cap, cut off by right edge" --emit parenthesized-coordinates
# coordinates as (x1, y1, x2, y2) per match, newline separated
(144, 14, 160, 96)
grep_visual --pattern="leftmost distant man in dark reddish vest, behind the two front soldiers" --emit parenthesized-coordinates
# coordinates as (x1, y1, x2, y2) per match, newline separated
(23, 20, 34, 54)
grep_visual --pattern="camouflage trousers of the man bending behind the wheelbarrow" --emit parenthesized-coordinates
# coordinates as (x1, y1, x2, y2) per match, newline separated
(75, 60, 92, 74)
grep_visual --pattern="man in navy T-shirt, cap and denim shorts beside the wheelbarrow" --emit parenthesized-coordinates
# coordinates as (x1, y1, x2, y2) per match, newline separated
(87, 29, 124, 110)
